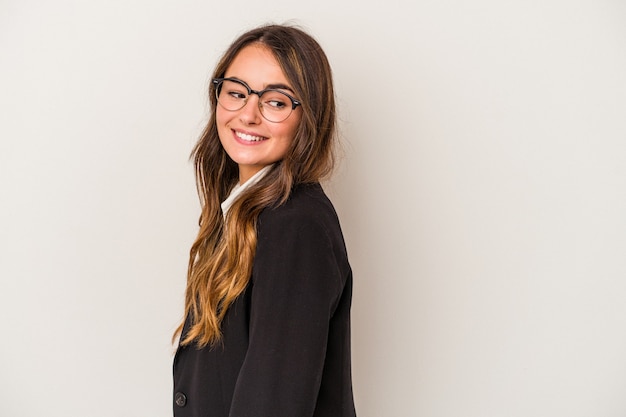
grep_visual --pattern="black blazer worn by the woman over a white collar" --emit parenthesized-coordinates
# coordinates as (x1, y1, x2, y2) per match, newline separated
(173, 184, 356, 417)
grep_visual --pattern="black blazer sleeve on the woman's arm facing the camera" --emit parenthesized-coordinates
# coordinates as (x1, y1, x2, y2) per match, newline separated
(230, 210, 345, 417)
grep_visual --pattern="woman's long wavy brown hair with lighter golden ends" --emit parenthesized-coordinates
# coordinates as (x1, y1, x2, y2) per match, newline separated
(174, 25, 336, 346)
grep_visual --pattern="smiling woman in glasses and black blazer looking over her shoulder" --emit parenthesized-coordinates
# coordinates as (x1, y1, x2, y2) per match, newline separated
(174, 25, 355, 417)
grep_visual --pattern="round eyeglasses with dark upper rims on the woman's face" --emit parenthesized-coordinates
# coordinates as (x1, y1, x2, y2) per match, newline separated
(213, 78, 302, 123)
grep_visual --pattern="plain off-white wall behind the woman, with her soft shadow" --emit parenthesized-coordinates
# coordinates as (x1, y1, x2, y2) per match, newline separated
(0, 0, 626, 417)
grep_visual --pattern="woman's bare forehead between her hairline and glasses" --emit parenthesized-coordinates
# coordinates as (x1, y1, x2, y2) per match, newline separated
(224, 43, 290, 89)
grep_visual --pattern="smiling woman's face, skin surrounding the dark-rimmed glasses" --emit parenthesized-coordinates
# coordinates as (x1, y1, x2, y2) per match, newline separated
(216, 44, 302, 183)
